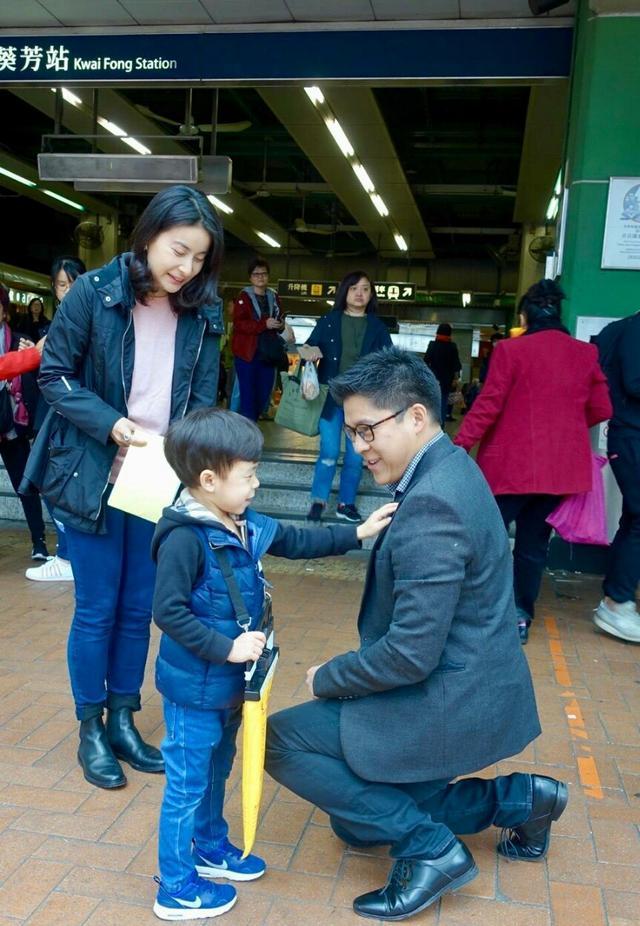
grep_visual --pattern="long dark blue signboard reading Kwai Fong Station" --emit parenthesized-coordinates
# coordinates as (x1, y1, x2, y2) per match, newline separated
(0, 26, 573, 85)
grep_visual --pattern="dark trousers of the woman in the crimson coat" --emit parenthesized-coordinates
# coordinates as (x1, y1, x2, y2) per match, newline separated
(496, 494, 561, 620)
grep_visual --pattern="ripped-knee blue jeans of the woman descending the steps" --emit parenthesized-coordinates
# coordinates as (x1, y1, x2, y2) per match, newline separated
(311, 405, 362, 505)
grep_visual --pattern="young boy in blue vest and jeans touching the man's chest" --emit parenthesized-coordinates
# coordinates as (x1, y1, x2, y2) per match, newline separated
(152, 408, 396, 920)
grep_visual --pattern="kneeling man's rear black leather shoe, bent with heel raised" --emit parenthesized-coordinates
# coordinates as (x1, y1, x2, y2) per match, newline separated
(498, 775, 569, 862)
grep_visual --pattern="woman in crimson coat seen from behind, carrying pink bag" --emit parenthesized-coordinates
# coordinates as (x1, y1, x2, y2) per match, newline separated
(454, 280, 611, 644)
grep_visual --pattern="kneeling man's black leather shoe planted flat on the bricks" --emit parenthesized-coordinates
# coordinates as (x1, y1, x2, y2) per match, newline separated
(353, 839, 478, 922)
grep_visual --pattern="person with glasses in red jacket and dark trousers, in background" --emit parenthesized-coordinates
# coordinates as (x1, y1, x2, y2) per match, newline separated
(230, 257, 295, 421)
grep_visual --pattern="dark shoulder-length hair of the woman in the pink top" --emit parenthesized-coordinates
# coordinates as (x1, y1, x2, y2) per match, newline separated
(129, 186, 224, 314)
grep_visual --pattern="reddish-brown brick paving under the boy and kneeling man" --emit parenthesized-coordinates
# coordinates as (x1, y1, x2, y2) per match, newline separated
(0, 525, 640, 926)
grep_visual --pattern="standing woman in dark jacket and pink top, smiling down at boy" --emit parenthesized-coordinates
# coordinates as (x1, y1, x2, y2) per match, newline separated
(27, 186, 222, 788)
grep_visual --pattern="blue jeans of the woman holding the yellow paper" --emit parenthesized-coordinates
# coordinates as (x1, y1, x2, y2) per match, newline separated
(65, 506, 156, 720)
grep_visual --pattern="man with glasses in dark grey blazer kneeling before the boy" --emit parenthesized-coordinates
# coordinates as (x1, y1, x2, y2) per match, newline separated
(267, 348, 567, 920)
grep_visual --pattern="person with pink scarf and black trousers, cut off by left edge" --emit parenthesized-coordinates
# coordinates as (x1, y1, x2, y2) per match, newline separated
(0, 286, 49, 560)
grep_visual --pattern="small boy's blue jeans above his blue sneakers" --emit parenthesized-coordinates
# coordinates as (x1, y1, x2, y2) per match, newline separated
(158, 698, 241, 893)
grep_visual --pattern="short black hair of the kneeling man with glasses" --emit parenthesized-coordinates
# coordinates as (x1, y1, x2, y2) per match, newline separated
(329, 347, 441, 422)
